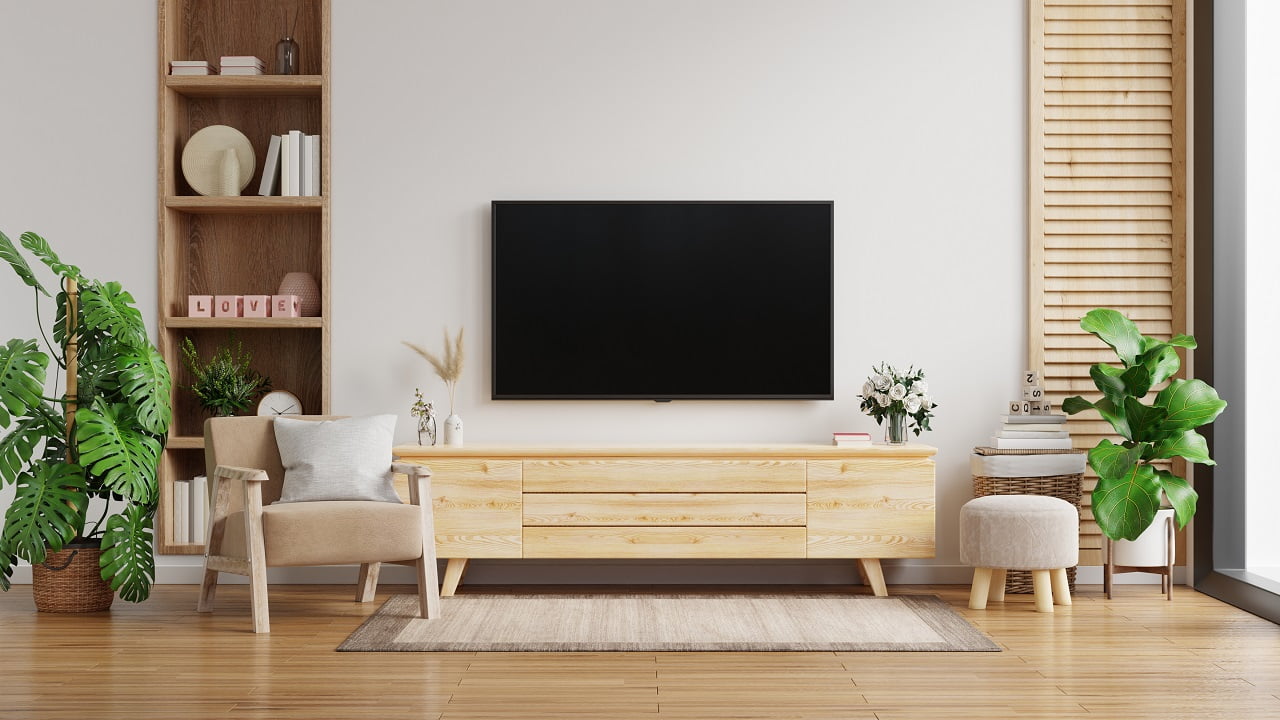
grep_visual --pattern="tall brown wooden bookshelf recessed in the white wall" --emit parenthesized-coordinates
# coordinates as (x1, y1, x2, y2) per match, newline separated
(156, 0, 332, 555)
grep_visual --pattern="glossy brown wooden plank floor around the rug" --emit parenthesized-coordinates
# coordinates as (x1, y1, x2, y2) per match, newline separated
(0, 585, 1280, 720)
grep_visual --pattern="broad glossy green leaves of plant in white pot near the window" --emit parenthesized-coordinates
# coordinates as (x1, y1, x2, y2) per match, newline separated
(1062, 309, 1226, 541)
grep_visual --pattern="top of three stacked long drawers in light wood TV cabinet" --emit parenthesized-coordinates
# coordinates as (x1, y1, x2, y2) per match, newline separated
(524, 457, 805, 492)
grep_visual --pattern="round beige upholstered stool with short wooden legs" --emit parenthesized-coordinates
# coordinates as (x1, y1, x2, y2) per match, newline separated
(960, 495, 1080, 612)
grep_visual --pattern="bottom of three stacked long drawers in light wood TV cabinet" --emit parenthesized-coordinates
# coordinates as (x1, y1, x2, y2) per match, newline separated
(525, 528, 805, 559)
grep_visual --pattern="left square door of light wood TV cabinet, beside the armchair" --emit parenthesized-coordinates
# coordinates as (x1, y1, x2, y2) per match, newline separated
(404, 459, 521, 557)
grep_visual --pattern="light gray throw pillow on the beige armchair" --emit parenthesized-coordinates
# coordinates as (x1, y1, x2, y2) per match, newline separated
(275, 415, 401, 502)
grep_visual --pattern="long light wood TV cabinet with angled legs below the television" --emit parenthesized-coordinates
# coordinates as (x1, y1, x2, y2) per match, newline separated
(396, 445, 937, 596)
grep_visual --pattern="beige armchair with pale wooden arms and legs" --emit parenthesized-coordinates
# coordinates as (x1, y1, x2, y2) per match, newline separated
(197, 416, 440, 633)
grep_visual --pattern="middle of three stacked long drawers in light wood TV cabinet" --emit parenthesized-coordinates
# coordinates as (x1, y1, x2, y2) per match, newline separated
(525, 492, 805, 527)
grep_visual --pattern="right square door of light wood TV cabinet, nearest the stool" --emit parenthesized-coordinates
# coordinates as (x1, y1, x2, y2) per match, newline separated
(809, 459, 936, 557)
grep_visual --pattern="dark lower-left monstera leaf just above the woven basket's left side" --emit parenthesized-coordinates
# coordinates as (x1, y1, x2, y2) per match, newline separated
(4, 460, 88, 565)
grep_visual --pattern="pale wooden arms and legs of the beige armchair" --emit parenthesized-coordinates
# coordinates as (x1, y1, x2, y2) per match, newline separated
(196, 462, 440, 633)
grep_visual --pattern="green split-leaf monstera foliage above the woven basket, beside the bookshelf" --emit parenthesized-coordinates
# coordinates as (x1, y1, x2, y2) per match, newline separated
(0, 232, 172, 602)
